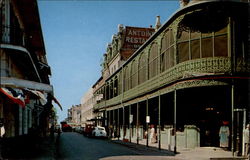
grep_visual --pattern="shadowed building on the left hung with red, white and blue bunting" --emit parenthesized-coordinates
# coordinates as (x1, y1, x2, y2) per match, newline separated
(0, 0, 55, 138)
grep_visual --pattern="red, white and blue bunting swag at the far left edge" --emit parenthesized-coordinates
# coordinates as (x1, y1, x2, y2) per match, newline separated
(0, 87, 25, 107)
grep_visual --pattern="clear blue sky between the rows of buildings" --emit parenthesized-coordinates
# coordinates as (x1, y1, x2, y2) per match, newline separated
(38, 0, 179, 122)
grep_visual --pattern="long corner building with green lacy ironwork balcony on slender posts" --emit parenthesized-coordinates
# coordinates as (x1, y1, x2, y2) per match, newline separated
(94, 0, 250, 155)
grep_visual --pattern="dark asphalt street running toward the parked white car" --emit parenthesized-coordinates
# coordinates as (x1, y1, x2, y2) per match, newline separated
(57, 132, 173, 160)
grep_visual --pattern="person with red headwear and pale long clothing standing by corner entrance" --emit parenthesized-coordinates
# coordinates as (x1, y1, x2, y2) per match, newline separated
(219, 121, 230, 149)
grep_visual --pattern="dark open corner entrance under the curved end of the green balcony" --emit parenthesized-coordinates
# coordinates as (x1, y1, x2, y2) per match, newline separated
(177, 86, 231, 147)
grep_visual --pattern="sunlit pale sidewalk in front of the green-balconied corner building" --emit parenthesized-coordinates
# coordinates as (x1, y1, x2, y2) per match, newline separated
(111, 139, 247, 160)
